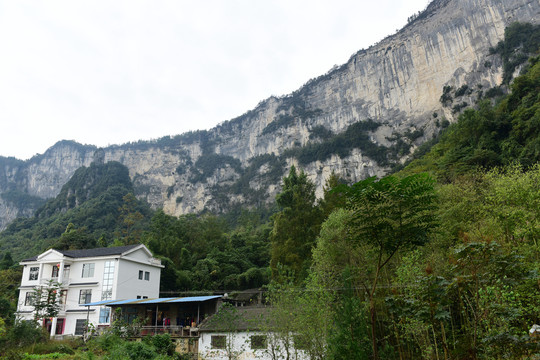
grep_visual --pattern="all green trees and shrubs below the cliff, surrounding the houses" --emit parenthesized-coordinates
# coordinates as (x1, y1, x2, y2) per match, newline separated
(0, 21, 540, 360)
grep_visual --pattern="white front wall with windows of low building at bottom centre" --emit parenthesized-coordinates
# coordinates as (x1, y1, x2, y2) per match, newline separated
(199, 331, 308, 360)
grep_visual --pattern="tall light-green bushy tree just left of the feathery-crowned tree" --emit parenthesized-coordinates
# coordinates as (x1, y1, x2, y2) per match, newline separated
(308, 208, 371, 359)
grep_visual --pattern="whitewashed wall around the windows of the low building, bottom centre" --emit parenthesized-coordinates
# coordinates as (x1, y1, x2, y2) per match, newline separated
(199, 331, 308, 360)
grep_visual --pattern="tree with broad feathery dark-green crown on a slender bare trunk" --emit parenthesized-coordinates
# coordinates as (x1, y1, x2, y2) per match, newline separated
(342, 174, 435, 359)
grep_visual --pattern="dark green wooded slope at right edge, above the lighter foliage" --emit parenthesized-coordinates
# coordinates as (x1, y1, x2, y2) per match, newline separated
(398, 57, 540, 181)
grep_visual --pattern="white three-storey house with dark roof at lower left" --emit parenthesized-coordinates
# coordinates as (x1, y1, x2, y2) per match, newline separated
(17, 244, 163, 336)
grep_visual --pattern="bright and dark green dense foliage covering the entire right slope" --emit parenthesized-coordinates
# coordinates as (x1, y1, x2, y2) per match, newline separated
(264, 28, 540, 359)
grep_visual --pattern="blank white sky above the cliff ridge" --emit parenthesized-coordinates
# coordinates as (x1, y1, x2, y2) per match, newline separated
(0, 0, 429, 159)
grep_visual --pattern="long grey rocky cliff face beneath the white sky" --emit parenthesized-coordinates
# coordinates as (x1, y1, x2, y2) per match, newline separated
(0, 0, 540, 228)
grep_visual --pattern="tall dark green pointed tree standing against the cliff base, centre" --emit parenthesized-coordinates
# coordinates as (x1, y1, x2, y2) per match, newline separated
(270, 166, 322, 282)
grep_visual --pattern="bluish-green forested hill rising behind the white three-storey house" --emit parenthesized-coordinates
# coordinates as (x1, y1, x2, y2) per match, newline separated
(0, 162, 150, 260)
